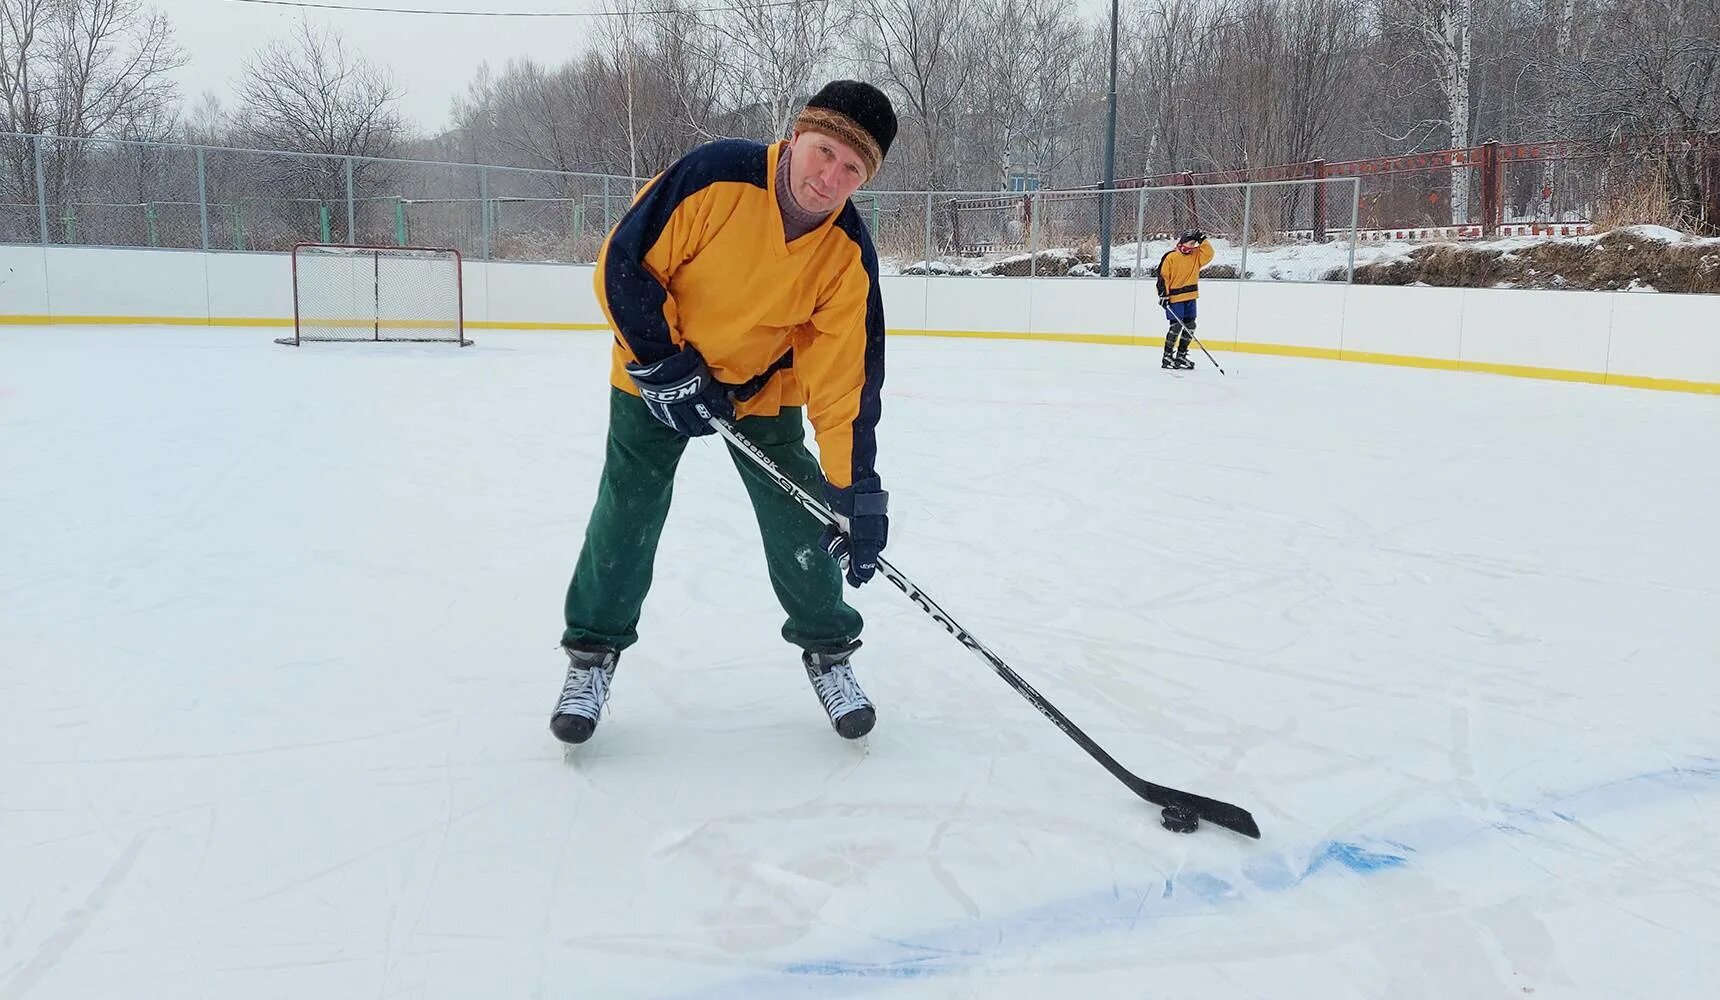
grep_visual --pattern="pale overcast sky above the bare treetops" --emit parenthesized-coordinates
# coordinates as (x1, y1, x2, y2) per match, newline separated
(171, 0, 1109, 133)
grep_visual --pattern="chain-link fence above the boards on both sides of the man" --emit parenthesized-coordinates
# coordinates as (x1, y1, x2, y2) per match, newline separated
(0, 134, 1362, 281)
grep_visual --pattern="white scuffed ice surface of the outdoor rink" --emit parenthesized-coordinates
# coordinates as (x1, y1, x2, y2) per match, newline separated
(0, 329, 1720, 1000)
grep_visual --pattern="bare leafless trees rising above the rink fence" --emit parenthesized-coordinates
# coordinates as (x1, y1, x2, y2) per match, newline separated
(0, 0, 1720, 204)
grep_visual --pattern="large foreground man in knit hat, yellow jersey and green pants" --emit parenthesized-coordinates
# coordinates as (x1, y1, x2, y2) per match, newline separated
(550, 81, 896, 744)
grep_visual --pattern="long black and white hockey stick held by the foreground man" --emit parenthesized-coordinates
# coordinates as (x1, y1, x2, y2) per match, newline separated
(710, 417, 1261, 838)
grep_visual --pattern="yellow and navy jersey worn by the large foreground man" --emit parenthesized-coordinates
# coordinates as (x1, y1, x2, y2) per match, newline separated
(593, 139, 884, 487)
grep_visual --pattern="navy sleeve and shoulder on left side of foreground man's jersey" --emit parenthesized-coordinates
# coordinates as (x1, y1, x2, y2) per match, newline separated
(604, 139, 767, 365)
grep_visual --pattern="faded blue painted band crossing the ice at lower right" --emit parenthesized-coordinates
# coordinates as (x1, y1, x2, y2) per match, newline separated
(676, 757, 1720, 1000)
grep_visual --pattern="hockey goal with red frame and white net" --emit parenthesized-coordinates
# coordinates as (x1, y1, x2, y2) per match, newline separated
(275, 243, 471, 348)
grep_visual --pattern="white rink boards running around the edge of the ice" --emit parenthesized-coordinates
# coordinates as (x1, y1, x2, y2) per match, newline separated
(10, 246, 1720, 389)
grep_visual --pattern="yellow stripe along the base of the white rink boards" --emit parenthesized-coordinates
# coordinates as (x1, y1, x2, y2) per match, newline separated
(0, 315, 1720, 394)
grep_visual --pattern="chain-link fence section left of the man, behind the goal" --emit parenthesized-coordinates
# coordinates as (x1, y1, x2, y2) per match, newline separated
(0, 134, 638, 263)
